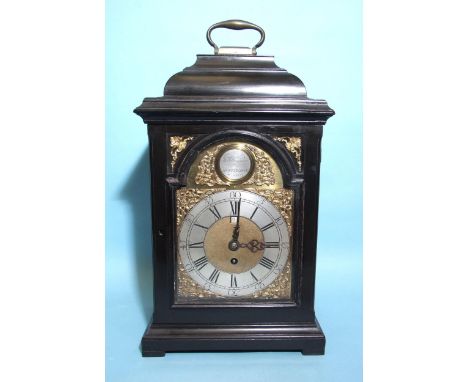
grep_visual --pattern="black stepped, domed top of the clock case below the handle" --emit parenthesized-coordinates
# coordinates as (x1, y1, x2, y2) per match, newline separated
(135, 55, 334, 120)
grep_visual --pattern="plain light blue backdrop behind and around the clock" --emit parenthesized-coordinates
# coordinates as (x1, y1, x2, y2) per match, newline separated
(106, 0, 362, 382)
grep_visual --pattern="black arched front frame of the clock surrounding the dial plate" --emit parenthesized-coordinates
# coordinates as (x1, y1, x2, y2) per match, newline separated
(148, 121, 322, 325)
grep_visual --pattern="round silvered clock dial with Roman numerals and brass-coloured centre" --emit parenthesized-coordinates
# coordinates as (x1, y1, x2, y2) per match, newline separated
(178, 190, 289, 297)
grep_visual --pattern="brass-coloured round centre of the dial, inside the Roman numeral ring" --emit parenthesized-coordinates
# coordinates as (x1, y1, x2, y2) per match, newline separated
(204, 217, 264, 273)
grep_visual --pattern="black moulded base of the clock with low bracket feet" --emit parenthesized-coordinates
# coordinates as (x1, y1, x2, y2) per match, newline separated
(141, 321, 325, 357)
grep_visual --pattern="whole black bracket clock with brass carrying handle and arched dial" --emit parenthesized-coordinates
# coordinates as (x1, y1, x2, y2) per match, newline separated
(135, 20, 334, 356)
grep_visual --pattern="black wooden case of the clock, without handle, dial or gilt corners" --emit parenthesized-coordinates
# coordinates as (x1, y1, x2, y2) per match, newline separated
(135, 20, 334, 356)
